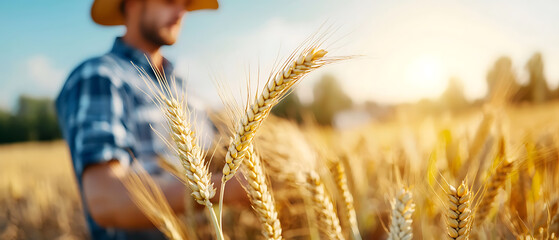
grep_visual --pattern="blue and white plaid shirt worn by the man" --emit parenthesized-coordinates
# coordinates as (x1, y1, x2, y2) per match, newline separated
(56, 38, 211, 240)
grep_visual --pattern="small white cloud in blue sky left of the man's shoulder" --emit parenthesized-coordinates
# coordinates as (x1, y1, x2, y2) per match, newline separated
(24, 55, 65, 97)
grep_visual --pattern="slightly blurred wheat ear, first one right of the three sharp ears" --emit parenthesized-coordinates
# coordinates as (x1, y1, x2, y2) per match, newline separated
(305, 171, 344, 239)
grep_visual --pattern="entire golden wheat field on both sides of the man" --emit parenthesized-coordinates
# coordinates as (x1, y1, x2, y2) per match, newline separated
(0, 99, 559, 239)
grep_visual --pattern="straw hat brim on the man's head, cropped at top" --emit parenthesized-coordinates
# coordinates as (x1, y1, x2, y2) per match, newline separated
(91, 0, 219, 26)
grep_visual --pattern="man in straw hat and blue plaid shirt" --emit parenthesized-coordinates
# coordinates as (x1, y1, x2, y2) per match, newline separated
(56, 0, 247, 240)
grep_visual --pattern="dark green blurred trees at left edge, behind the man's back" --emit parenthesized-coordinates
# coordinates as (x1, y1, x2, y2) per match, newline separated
(0, 96, 61, 143)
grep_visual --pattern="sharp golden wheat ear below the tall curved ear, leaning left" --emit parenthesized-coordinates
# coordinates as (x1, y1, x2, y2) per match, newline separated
(243, 146, 282, 240)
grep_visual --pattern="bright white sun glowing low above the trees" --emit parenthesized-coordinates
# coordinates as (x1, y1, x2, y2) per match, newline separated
(405, 55, 446, 97)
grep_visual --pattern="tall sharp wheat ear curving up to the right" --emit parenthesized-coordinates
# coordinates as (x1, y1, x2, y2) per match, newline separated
(222, 48, 326, 183)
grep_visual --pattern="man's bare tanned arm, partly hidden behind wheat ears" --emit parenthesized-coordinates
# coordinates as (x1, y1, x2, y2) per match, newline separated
(82, 160, 249, 229)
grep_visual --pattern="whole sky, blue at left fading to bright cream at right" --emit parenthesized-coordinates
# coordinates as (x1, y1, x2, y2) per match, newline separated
(0, 0, 559, 108)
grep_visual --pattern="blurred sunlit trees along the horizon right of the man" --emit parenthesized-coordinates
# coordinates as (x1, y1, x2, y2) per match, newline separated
(278, 52, 559, 125)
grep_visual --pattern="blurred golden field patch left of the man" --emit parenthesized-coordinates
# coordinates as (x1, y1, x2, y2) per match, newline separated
(0, 141, 86, 239)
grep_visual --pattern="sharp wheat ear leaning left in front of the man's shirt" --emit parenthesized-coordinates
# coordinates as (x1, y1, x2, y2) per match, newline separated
(137, 62, 223, 239)
